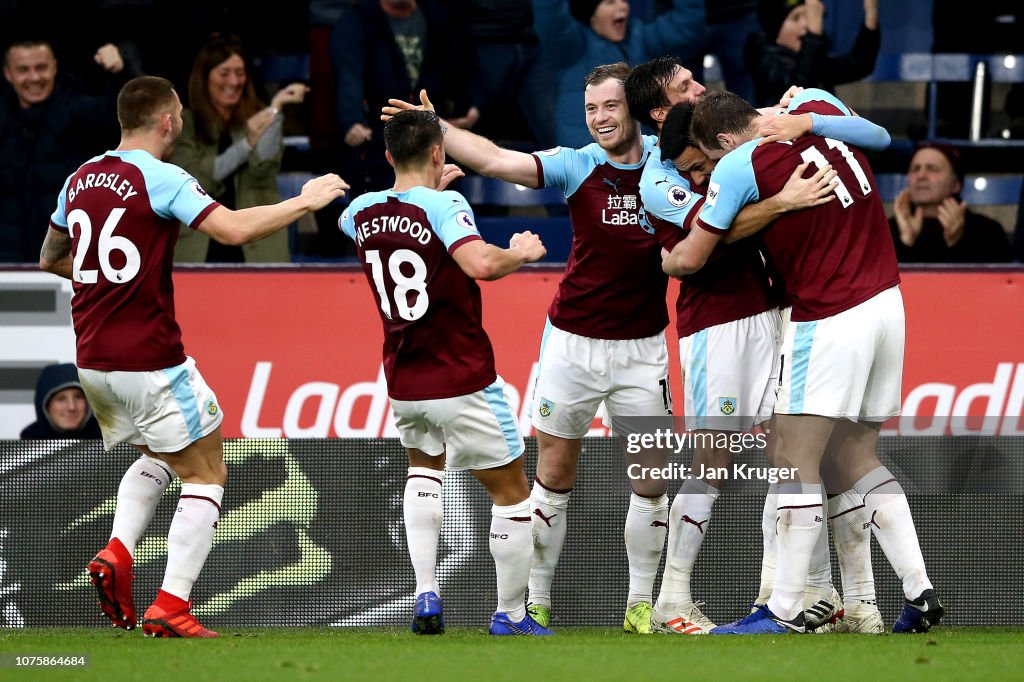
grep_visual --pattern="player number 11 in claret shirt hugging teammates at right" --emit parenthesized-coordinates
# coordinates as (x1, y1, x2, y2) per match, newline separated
(664, 90, 943, 634)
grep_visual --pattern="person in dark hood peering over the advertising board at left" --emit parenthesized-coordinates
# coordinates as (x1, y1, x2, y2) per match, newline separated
(22, 363, 99, 440)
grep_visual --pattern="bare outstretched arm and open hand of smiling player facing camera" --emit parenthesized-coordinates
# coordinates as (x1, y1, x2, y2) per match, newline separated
(381, 90, 539, 189)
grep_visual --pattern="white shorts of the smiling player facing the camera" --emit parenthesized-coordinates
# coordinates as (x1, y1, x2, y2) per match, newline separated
(530, 321, 672, 438)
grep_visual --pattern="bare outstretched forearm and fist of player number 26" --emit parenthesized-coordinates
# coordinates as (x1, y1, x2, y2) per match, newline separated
(197, 173, 348, 246)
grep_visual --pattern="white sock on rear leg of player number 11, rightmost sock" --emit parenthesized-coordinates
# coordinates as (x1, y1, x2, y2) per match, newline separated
(853, 467, 932, 599)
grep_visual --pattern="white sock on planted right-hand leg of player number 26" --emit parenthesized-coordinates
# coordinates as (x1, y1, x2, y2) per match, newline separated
(161, 483, 224, 601)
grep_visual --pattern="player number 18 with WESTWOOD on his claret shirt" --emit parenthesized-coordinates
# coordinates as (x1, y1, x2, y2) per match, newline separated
(339, 111, 551, 635)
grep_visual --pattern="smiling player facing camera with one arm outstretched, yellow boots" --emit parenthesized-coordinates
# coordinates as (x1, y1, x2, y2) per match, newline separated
(384, 62, 671, 634)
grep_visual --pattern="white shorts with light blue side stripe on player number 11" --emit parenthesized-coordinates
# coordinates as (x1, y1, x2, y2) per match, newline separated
(775, 287, 906, 422)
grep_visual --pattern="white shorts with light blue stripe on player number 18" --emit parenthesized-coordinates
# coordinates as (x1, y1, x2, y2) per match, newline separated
(391, 377, 524, 471)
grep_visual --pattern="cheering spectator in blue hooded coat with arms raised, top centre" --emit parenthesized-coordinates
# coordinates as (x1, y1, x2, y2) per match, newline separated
(534, 0, 706, 147)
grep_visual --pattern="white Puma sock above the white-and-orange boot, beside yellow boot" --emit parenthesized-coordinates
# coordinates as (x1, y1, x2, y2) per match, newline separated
(657, 478, 719, 611)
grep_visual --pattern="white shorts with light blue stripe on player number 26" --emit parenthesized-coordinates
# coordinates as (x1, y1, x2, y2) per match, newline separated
(78, 357, 224, 453)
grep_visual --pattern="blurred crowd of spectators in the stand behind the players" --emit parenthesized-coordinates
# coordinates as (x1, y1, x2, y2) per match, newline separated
(0, 0, 1024, 263)
